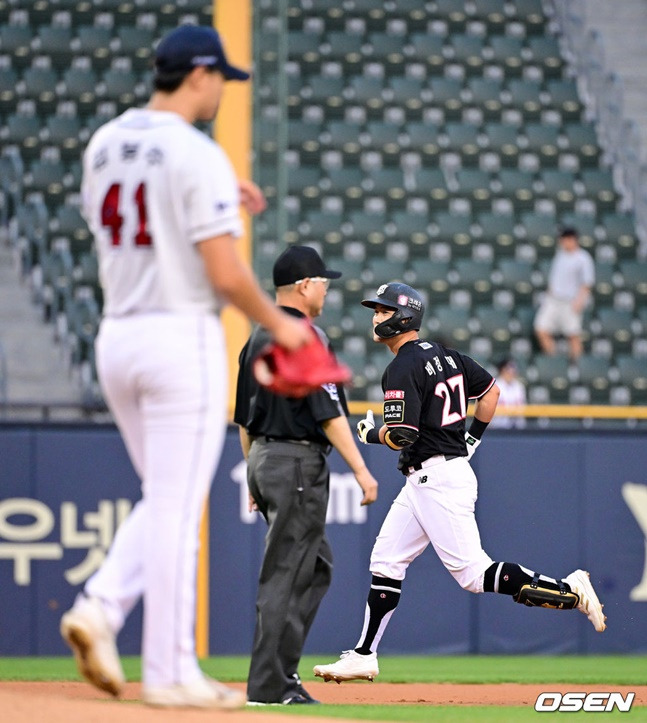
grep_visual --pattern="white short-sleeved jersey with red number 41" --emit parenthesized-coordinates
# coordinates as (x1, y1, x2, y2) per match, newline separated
(81, 108, 242, 316)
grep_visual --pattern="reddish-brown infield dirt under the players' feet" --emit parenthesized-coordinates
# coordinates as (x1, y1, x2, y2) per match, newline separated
(0, 682, 647, 723)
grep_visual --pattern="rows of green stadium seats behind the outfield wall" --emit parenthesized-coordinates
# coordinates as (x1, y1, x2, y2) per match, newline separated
(0, 0, 647, 404)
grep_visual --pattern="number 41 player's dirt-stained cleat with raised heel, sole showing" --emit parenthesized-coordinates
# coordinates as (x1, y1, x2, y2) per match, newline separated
(60, 595, 125, 696)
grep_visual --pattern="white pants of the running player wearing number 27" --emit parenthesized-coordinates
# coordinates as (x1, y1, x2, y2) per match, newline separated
(370, 455, 493, 592)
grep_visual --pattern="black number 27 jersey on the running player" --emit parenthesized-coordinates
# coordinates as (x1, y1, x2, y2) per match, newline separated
(382, 339, 494, 470)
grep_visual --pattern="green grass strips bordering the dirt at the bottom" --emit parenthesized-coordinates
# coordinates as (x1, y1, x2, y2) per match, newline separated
(0, 655, 647, 723)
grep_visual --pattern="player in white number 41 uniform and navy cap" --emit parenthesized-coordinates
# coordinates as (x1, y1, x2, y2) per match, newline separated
(61, 25, 309, 708)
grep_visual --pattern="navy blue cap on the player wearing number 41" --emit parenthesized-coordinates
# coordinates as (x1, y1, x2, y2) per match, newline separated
(155, 25, 249, 80)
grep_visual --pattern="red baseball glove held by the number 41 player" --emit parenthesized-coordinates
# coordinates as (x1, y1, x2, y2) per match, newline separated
(253, 327, 351, 397)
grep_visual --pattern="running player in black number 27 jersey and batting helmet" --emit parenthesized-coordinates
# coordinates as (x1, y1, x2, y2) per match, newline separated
(314, 283, 606, 682)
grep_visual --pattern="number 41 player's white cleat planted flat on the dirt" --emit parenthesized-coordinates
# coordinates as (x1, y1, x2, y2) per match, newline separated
(142, 677, 247, 710)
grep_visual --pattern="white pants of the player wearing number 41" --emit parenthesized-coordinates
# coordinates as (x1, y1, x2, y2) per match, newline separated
(86, 314, 227, 687)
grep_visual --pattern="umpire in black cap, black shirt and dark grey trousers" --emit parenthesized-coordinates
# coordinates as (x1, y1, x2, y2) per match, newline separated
(234, 245, 377, 704)
